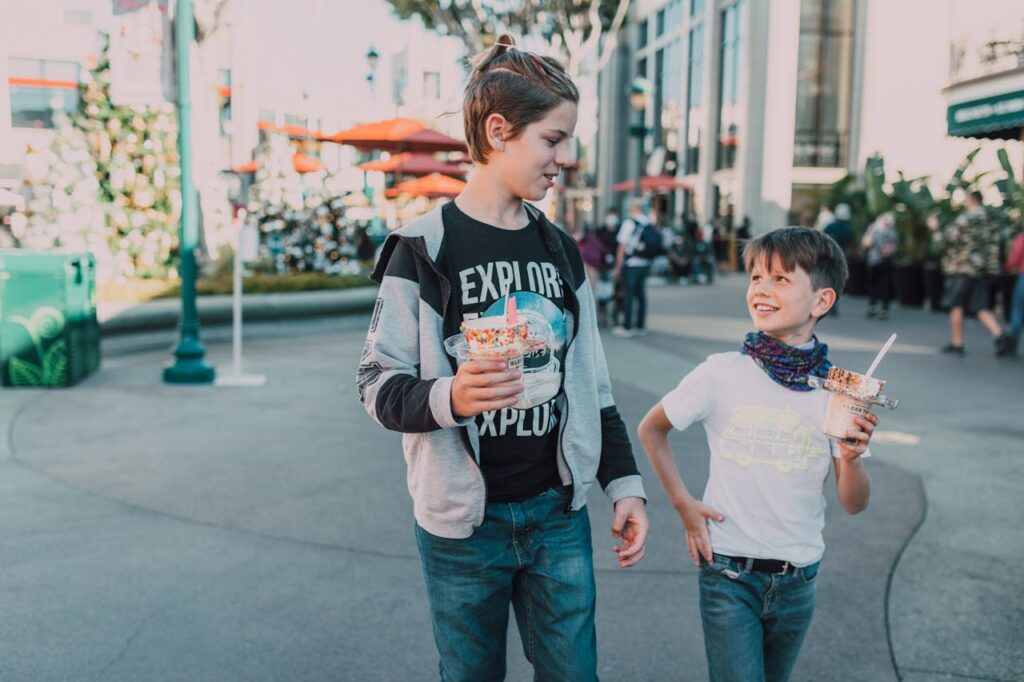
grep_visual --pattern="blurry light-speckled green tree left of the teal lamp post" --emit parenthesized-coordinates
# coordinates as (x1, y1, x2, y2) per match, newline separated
(19, 37, 180, 279)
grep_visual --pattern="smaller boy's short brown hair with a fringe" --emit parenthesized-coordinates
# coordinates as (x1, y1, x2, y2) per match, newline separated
(743, 227, 850, 298)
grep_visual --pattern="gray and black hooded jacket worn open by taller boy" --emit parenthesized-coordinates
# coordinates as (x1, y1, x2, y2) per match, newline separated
(357, 205, 645, 539)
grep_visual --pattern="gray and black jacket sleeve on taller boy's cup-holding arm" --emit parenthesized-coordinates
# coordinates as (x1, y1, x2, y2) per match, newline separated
(356, 242, 467, 433)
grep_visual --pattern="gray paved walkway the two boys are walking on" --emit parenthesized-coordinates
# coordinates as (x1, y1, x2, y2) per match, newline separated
(0, 276, 1024, 682)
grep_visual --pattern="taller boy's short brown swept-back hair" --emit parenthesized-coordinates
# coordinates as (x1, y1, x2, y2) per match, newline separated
(462, 35, 580, 164)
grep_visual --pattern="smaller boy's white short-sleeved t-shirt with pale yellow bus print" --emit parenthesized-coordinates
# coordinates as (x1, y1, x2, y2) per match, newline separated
(662, 352, 869, 566)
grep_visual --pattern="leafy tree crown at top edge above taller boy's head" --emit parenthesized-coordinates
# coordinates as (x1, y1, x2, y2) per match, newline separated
(388, 0, 630, 79)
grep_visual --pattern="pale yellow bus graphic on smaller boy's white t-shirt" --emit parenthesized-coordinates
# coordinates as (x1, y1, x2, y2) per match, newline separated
(718, 407, 821, 473)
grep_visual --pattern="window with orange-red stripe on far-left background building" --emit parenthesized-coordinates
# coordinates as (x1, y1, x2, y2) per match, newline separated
(8, 57, 79, 128)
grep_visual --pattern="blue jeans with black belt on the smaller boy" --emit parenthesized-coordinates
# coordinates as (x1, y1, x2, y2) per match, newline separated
(699, 554, 819, 682)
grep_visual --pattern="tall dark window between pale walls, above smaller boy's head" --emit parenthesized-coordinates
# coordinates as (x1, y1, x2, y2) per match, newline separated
(793, 0, 854, 167)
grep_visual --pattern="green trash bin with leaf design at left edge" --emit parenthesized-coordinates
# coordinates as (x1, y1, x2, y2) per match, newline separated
(0, 250, 100, 387)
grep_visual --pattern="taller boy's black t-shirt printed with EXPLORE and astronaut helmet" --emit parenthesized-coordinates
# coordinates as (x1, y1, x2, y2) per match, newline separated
(437, 202, 566, 502)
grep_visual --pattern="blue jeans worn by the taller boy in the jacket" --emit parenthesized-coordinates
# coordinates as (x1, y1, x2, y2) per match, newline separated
(416, 487, 597, 682)
